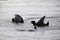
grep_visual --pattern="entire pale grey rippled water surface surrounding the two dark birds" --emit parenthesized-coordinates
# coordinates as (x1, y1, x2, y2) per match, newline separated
(0, 0, 60, 40)
